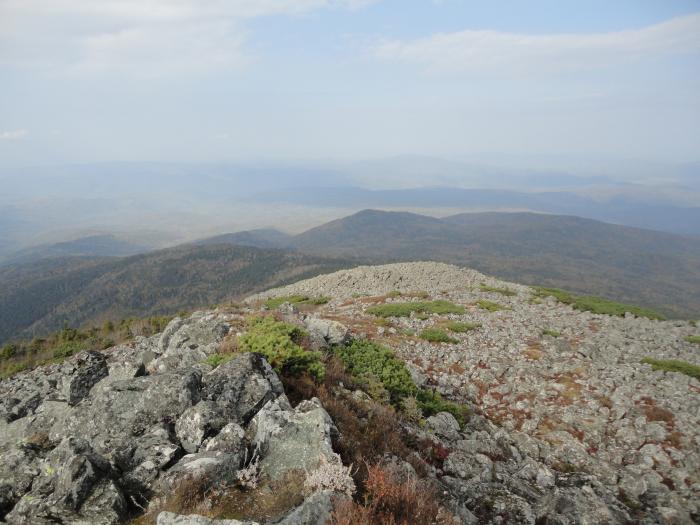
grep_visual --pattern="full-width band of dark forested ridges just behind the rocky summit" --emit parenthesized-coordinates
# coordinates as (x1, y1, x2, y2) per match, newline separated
(0, 210, 700, 342)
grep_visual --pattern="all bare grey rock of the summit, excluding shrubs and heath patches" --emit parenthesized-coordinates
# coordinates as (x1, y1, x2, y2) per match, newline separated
(0, 263, 700, 525)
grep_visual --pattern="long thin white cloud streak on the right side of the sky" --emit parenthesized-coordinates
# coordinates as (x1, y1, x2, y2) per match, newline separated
(372, 14, 700, 73)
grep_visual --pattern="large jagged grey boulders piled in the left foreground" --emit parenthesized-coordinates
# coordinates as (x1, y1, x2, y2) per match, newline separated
(0, 312, 340, 525)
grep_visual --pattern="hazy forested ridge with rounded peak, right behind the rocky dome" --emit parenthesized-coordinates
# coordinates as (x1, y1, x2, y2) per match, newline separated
(293, 210, 700, 317)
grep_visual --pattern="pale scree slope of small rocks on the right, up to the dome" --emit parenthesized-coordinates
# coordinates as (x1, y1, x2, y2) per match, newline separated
(251, 263, 700, 523)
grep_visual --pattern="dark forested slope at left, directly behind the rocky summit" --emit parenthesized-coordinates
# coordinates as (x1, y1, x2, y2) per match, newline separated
(0, 245, 349, 342)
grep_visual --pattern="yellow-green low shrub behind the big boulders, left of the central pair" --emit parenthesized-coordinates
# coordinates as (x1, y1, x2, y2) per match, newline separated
(238, 316, 325, 381)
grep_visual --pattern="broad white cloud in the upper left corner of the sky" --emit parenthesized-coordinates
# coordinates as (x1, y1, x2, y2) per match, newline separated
(0, 0, 376, 76)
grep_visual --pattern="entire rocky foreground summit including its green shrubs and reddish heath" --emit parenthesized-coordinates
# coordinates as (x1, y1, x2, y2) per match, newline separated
(0, 263, 700, 525)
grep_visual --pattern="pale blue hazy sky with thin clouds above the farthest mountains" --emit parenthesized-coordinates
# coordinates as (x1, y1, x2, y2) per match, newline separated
(0, 0, 700, 168)
